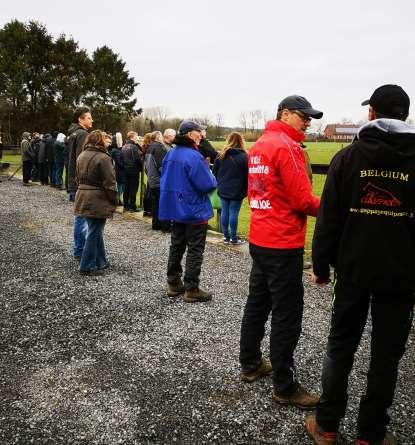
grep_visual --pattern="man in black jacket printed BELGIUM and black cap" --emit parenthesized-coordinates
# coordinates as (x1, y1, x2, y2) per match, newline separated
(306, 85, 415, 445)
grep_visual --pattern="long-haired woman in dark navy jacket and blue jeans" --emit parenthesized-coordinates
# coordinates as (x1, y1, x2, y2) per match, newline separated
(212, 131, 248, 244)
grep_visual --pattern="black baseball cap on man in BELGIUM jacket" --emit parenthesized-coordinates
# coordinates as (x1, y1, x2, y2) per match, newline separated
(362, 85, 410, 118)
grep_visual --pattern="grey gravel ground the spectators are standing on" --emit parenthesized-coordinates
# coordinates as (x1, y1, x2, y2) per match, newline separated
(0, 181, 415, 445)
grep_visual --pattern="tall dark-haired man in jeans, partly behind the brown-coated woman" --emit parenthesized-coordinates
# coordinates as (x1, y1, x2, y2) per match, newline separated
(66, 107, 93, 260)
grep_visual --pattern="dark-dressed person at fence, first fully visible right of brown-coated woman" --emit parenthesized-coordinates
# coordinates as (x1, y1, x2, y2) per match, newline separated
(121, 131, 143, 212)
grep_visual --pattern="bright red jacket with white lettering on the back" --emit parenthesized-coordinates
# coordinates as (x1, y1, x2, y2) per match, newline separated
(248, 121, 320, 249)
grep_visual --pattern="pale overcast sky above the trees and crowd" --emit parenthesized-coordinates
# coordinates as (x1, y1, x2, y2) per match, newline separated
(0, 0, 415, 125)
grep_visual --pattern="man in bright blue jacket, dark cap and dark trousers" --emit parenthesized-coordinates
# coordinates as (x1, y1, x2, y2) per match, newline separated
(159, 120, 217, 303)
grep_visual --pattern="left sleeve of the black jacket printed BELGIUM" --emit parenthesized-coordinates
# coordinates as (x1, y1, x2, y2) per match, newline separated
(312, 151, 343, 279)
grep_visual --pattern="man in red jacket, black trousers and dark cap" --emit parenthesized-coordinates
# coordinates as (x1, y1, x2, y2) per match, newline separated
(239, 96, 323, 409)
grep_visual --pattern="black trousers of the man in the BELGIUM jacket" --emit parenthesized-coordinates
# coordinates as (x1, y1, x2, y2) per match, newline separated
(317, 280, 414, 441)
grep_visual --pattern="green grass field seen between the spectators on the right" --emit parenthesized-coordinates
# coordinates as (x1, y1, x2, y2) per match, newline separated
(209, 141, 343, 251)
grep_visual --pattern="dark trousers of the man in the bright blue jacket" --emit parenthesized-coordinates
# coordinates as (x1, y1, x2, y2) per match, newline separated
(167, 222, 207, 290)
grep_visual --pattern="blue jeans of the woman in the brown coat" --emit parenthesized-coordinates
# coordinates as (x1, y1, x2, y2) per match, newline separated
(80, 218, 108, 271)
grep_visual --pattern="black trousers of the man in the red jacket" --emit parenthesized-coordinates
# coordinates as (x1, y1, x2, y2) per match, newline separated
(239, 244, 304, 394)
